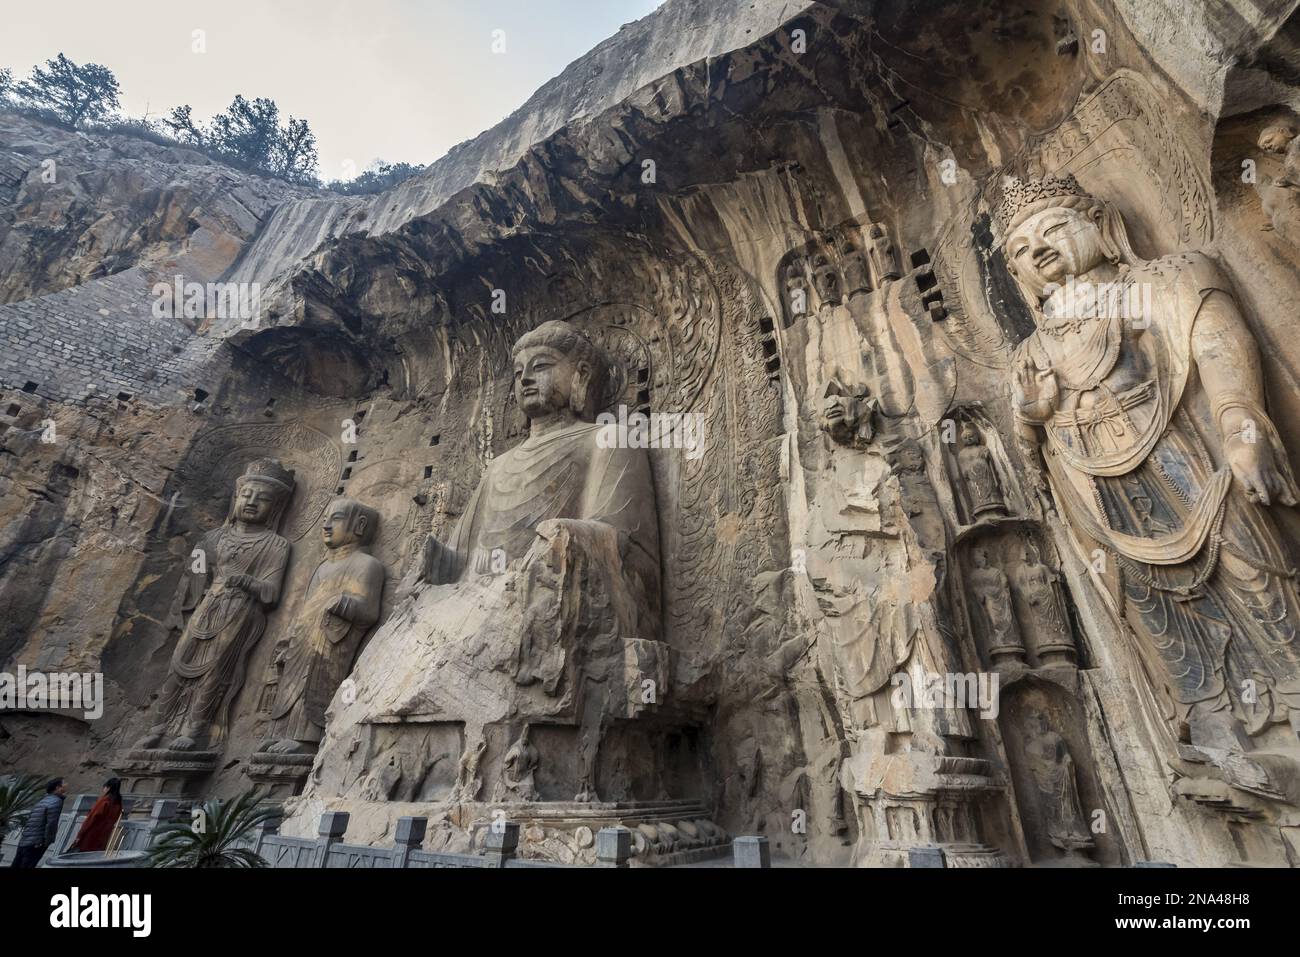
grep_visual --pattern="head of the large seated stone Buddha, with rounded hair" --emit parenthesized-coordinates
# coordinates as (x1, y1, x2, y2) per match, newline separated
(515, 320, 606, 421)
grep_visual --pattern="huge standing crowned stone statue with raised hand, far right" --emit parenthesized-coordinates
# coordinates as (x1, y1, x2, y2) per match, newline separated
(997, 177, 1300, 752)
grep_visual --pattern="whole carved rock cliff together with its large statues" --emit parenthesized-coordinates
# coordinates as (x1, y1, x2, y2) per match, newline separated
(0, 0, 1300, 866)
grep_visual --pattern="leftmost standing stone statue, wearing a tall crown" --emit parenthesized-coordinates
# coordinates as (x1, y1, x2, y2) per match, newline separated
(135, 459, 294, 750)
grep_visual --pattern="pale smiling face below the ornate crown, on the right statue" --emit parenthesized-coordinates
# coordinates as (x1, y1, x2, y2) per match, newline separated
(1005, 207, 1105, 299)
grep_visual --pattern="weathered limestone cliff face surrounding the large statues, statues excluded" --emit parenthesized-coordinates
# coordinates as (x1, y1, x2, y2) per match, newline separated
(0, 0, 1300, 866)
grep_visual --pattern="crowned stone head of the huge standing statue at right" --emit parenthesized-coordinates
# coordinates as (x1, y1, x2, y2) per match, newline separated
(995, 176, 1136, 308)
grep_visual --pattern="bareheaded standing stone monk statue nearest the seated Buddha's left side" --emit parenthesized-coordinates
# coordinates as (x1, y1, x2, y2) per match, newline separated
(263, 498, 384, 754)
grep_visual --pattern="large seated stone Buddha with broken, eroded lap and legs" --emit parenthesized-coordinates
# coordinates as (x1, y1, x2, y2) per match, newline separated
(318, 321, 667, 800)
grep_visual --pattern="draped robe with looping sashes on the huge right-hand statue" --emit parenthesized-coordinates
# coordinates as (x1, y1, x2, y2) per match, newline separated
(1017, 252, 1300, 733)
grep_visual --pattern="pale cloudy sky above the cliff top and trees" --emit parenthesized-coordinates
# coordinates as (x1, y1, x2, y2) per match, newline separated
(0, 0, 662, 179)
